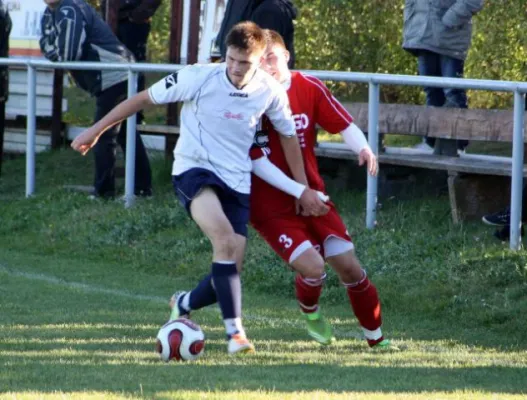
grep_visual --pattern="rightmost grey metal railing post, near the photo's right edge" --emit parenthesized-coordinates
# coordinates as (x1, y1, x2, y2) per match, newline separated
(510, 90, 525, 250)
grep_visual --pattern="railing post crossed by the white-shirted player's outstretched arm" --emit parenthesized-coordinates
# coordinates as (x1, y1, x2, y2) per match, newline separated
(124, 70, 137, 208)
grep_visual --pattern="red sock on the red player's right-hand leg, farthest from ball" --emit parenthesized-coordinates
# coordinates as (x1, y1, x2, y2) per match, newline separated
(344, 271, 384, 346)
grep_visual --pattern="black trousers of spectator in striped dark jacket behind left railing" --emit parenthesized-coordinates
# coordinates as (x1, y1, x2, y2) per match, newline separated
(93, 81, 152, 197)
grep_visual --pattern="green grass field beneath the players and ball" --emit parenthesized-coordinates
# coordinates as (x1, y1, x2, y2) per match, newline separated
(0, 150, 527, 400)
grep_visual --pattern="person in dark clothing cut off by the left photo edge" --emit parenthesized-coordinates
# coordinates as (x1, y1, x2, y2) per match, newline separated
(0, 0, 12, 175)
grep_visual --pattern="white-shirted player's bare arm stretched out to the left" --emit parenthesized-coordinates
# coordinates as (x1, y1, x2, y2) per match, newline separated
(71, 90, 154, 155)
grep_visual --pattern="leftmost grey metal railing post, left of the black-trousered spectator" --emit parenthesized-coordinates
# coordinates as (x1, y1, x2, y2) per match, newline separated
(26, 63, 37, 197)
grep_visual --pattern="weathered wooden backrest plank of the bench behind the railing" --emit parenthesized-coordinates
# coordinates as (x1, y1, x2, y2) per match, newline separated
(343, 103, 527, 142)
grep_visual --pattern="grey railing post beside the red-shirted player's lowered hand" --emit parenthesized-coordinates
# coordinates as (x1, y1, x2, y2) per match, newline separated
(366, 82, 380, 229)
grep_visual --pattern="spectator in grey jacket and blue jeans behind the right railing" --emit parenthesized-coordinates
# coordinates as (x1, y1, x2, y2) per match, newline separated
(403, 0, 483, 155)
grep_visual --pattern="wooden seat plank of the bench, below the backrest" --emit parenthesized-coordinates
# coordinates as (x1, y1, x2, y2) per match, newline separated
(315, 143, 527, 176)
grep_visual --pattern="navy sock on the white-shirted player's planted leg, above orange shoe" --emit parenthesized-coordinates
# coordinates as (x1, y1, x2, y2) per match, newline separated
(212, 262, 242, 319)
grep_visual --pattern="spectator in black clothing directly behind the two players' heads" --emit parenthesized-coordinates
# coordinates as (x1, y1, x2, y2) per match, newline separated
(216, 0, 297, 68)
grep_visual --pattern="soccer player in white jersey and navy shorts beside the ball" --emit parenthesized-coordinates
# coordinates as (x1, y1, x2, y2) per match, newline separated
(71, 22, 328, 354)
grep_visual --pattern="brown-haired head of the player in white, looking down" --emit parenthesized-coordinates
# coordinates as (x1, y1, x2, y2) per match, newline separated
(225, 21, 266, 87)
